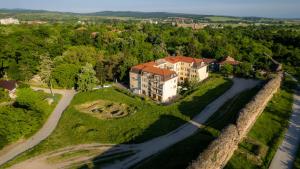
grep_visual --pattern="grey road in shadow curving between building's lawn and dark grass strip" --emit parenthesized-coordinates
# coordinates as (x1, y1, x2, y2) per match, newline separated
(101, 78, 259, 169)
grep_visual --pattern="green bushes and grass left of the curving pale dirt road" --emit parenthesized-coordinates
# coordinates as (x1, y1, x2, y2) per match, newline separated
(0, 88, 59, 149)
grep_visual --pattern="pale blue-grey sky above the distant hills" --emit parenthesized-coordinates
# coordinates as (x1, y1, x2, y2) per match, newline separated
(0, 0, 300, 18)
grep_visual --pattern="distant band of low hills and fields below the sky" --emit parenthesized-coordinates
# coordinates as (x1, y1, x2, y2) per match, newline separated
(0, 9, 299, 23)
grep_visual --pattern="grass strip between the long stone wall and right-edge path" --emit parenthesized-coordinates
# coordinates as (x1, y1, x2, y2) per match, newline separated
(225, 81, 294, 169)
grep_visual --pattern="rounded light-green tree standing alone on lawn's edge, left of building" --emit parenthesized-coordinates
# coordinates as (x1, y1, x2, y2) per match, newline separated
(77, 63, 98, 92)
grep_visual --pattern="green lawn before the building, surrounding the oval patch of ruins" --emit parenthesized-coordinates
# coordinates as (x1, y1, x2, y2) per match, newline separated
(1, 76, 232, 168)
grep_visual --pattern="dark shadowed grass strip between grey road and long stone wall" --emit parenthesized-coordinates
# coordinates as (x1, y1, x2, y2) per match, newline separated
(135, 87, 259, 169)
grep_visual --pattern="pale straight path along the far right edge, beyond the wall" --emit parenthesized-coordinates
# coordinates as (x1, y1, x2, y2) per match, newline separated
(270, 78, 300, 169)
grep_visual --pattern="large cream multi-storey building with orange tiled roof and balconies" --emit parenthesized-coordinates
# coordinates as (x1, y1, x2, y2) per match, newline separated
(130, 56, 209, 102)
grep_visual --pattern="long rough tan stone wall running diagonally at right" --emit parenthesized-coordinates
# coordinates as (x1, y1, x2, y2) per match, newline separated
(188, 72, 283, 169)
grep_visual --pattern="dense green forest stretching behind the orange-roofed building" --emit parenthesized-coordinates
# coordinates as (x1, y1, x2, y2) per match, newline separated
(0, 21, 300, 88)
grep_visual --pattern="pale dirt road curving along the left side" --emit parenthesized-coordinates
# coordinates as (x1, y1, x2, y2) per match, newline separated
(0, 88, 76, 166)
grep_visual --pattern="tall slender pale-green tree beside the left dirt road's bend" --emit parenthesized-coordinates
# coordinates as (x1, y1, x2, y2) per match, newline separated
(39, 55, 54, 96)
